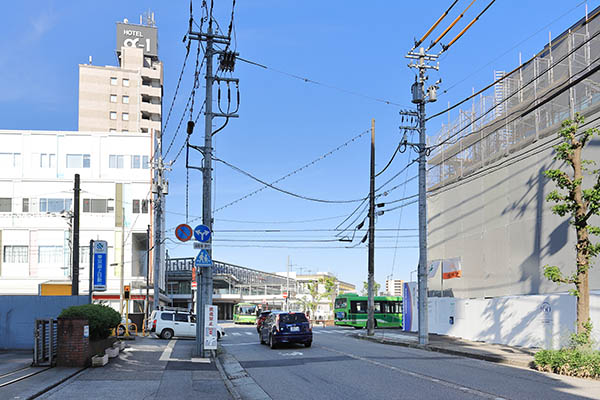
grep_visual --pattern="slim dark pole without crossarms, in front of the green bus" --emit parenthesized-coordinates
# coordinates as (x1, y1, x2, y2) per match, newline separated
(367, 119, 375, 336)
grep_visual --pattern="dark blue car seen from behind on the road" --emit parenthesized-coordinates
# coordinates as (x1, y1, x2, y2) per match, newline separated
(258, 311, 312, 349)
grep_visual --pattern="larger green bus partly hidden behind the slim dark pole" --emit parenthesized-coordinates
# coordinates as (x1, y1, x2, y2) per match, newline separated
(334, 293, 402, 329)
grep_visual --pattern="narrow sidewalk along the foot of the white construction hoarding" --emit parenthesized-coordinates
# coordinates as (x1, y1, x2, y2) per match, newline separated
(356, 329, 536, 368)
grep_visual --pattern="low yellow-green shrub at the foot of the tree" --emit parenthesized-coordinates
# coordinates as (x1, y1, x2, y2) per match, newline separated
(534, 348, 600, 378)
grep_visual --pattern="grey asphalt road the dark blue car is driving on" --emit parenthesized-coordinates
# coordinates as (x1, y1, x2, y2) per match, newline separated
(221, 324, 600, 400)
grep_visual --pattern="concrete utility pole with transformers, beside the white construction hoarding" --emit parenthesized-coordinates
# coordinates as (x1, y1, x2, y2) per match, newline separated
(405, 47, 439, 344)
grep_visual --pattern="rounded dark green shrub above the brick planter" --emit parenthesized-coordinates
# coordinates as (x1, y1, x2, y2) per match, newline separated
(59, 304, 121, 340)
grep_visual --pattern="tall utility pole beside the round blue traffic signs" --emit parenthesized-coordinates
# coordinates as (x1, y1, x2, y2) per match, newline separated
(186, 5, 239, 357)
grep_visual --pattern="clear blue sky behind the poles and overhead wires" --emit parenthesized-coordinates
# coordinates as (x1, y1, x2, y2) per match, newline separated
(0, 0, 600, 288)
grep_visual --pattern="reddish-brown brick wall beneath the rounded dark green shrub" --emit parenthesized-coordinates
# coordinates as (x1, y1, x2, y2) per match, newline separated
(56, 318, 90, 367)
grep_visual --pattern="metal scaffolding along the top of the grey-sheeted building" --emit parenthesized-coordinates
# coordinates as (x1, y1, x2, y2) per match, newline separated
(427, 11, 600, 189)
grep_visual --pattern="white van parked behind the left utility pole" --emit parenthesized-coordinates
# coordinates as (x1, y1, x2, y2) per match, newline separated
(148, 310, 225, 340)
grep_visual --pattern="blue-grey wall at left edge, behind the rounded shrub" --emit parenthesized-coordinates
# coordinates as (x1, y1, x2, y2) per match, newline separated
(0, 296, 88, 350)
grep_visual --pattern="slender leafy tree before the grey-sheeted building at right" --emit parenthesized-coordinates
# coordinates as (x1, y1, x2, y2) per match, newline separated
(544, 114, 600, 338)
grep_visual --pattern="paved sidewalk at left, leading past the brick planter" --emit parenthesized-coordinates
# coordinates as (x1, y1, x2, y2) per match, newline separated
(0, 337, 232, 400)
